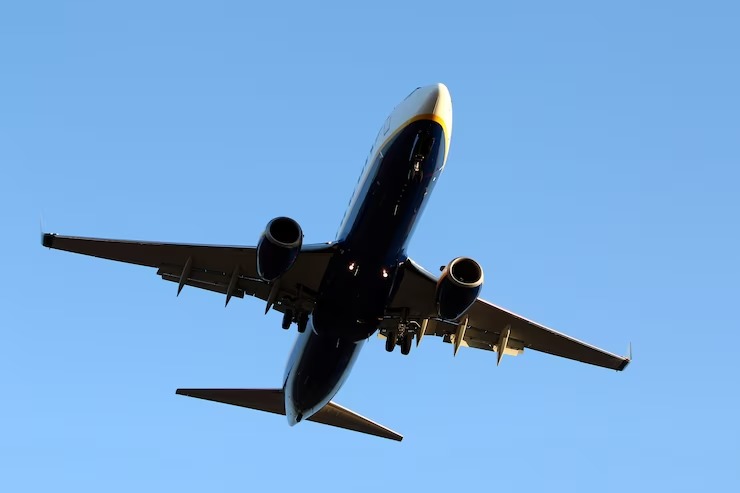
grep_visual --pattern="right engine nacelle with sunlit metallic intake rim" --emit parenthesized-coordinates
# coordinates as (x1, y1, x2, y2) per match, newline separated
(435, 257, 483, 320)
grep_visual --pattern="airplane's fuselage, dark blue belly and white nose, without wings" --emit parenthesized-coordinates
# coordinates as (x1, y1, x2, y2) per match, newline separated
(283, 84, 452, 425)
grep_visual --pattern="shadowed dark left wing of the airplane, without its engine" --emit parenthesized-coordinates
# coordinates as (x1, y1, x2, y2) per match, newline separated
(42, 233, 333, 311)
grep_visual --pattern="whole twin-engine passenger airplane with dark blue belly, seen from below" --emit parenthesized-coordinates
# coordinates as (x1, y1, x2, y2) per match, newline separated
(42, 84, 631, 441)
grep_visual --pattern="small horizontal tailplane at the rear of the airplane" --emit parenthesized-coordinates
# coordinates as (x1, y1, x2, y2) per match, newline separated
(177, 389, 403, 442)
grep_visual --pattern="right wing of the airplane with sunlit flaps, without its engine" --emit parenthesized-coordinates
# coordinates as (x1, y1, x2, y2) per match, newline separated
(391, 259, 630, 371)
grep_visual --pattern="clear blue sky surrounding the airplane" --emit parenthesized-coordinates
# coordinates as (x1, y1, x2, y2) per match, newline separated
(0, 1, 740, 492)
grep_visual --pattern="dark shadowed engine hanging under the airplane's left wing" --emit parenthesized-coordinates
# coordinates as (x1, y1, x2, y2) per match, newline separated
(257, 217, 303, 282)
